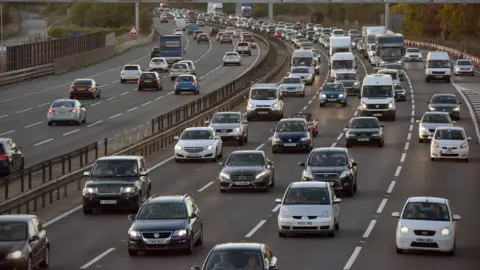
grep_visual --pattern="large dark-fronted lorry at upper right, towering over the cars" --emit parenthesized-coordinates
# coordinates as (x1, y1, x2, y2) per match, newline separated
(375, 34, 405, 67)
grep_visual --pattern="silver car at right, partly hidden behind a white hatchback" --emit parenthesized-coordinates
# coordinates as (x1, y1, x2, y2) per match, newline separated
(417, 112, 455, 142)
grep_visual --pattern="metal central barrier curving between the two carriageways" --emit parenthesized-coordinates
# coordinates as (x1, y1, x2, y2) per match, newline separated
(0, 27, 279, 213)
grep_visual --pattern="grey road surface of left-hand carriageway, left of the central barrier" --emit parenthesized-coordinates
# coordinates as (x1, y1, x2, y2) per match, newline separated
(0, 23, 266, 166)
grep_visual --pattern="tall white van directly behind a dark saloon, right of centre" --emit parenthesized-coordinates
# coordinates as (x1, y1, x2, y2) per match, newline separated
(358, 74, 395, 121)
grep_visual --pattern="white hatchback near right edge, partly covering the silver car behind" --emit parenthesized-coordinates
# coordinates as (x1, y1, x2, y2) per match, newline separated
(428, 127, 472, 162)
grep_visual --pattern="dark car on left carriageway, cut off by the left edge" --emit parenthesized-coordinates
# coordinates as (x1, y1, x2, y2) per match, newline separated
(0, 138, 25, 177)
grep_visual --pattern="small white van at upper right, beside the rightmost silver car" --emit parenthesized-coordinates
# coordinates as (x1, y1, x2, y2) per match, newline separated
(425, 52, 453, 82)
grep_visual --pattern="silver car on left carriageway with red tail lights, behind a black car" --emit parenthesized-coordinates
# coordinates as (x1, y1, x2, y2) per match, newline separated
(47, 99, 87, 126)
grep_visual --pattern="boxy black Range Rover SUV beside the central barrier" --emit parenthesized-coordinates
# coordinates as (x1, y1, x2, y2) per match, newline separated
(82, 156, 152, 215)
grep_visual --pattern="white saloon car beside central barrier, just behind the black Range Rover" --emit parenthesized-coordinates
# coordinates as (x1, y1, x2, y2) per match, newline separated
(174, 127, 223, 162)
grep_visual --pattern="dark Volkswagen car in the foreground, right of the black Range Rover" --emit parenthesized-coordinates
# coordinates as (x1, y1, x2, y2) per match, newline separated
(128, 195, 203, 256)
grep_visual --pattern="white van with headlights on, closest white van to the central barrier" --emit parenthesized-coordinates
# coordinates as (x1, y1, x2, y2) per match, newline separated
(247, 83, 283, 120)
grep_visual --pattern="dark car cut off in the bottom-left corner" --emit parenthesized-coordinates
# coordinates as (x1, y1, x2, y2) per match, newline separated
(0, 215, 50, 269)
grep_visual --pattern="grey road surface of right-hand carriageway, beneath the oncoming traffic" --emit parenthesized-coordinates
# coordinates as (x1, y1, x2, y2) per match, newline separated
(26, 30, 480, 270)
